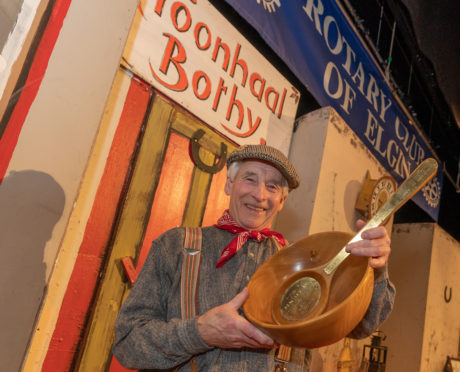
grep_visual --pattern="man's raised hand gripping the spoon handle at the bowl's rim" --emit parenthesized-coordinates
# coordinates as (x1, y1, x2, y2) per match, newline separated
(346, 220, 391, 269)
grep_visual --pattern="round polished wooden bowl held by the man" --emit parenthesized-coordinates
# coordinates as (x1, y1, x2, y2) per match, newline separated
(243, 232, 374, 348)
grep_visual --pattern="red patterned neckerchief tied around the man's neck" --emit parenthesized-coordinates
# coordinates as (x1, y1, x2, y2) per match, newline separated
(214, 209, 286, 267)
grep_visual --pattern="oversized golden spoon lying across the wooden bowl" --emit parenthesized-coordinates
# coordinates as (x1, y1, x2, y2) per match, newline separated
(272, 158, 438, 324)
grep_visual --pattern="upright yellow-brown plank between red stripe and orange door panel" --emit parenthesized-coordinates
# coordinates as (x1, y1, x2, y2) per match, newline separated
(79, 93, 173, 371)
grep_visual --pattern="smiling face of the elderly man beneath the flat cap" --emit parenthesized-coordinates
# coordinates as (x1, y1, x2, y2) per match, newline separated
(225, 160, 286, 230)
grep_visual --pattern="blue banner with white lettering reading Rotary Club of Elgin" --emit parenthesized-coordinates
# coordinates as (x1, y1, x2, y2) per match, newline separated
(226, 0, 442, 221)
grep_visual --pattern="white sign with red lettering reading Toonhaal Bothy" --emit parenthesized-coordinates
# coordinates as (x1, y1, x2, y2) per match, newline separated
(123, 0, 300, 154)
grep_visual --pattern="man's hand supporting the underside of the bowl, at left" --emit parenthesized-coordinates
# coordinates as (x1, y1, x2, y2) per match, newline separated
(198, 288, 277, 349)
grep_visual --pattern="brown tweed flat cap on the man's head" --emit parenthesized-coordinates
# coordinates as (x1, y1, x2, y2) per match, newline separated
(227, 145, 300, 190)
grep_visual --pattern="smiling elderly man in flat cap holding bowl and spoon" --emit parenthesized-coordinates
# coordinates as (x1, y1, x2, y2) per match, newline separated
(113, 145, 394, 372)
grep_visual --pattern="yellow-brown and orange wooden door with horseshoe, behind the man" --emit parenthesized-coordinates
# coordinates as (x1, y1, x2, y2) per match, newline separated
(76, 70, 235, 372)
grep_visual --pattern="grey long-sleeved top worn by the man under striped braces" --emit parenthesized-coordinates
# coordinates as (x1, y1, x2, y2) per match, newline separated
(113, 226, 395, 372)
